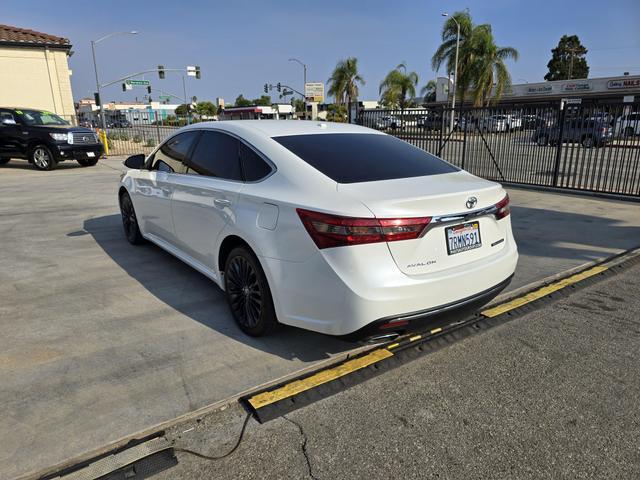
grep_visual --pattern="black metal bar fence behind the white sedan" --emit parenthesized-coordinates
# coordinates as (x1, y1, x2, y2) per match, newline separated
(357, 103, 640, 196)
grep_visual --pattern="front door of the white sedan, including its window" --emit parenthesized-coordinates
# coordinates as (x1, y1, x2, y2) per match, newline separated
(133, 130, 200, 245)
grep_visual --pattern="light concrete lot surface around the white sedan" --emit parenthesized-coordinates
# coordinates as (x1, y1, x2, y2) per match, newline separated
(0, 157, 640, 478)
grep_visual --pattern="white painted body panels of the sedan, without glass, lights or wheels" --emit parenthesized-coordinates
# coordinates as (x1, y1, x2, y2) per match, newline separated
(121, 120, 518, 335)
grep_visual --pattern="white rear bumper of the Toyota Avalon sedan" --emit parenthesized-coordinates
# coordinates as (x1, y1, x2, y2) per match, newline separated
(260, 229, 518, 336)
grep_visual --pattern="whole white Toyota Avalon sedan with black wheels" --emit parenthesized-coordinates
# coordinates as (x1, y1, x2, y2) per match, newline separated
(118, 120, 518, 338)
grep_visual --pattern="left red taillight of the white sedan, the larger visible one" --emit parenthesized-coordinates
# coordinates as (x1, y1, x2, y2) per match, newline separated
(296, 208, 431, 249)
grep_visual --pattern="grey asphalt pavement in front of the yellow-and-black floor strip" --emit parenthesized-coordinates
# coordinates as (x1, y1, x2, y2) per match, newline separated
(159, 258, 640, 480)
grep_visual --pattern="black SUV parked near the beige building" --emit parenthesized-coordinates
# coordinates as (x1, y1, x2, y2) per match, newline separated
(0, 107, 103, 170)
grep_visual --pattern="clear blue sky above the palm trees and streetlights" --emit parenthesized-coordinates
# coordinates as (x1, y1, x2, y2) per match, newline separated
(5, 0, 640, 102)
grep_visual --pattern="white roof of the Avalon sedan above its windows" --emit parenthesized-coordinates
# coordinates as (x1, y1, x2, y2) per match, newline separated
(182, 120, 384, 137)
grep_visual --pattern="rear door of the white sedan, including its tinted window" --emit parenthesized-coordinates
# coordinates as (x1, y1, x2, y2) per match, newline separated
(171, 130, 243, 269)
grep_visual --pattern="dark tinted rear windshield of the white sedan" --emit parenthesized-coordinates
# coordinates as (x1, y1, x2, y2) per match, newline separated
(273, 133, 458, 183)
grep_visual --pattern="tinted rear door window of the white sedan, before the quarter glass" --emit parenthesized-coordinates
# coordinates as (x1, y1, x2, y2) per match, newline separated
(187, 131, 242, 180)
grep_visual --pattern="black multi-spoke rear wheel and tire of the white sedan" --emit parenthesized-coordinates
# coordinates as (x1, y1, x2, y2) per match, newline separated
(224, 247, 279, 337)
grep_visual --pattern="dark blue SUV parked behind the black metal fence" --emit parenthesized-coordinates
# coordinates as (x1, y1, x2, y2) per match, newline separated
(532, 118, 613, 148)
